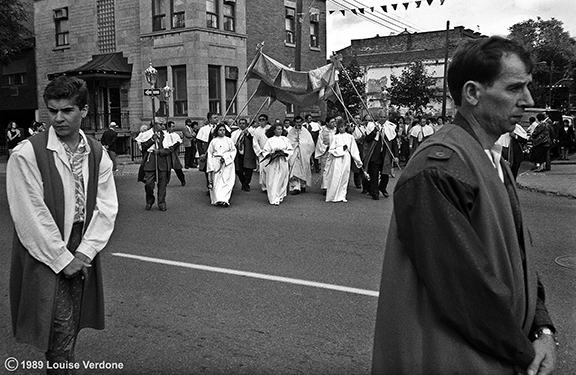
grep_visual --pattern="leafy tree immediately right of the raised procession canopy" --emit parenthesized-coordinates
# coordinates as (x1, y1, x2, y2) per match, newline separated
(328, 60, 366, 118)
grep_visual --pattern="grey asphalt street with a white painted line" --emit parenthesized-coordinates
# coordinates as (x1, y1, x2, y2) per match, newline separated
(0, 170, 576, 375)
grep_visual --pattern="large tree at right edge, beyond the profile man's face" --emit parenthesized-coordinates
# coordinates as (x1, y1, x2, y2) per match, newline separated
(508, 17, 576, 108)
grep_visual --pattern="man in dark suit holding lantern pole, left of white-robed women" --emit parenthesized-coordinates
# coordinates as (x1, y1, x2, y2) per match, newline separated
(142, 123, 174, 211)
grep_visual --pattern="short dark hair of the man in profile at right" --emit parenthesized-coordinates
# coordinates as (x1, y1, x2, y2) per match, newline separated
(448, 36, 532, 106)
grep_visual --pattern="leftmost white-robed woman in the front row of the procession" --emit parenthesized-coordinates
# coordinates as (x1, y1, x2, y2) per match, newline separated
(206, 124, 236, 207)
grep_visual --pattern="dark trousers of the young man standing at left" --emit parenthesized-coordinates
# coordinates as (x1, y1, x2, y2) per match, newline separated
(45, 223, 84, 374)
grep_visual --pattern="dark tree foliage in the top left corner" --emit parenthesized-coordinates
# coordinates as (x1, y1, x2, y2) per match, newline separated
(0, 0, 32, 63)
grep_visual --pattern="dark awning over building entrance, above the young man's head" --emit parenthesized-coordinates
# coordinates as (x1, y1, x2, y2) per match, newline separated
(48, 52, 132, 80)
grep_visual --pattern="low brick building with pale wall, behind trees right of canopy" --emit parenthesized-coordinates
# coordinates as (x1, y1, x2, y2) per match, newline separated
(337, 26, 484, 115)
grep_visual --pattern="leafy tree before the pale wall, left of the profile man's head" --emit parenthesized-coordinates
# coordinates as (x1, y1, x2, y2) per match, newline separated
(389, 61, 436, 114)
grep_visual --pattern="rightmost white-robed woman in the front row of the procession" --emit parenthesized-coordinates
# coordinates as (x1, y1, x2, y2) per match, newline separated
(326, 117, 362, 202)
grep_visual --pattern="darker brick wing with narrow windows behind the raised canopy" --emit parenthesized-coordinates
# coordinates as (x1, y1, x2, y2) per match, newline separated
(246, 0, 326, 121)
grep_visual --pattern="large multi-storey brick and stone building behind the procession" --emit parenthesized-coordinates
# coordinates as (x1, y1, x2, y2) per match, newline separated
(34, 0, 326, 154)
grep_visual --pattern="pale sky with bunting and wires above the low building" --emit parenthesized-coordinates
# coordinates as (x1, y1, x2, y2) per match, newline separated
(326, 0, 576, 56)
